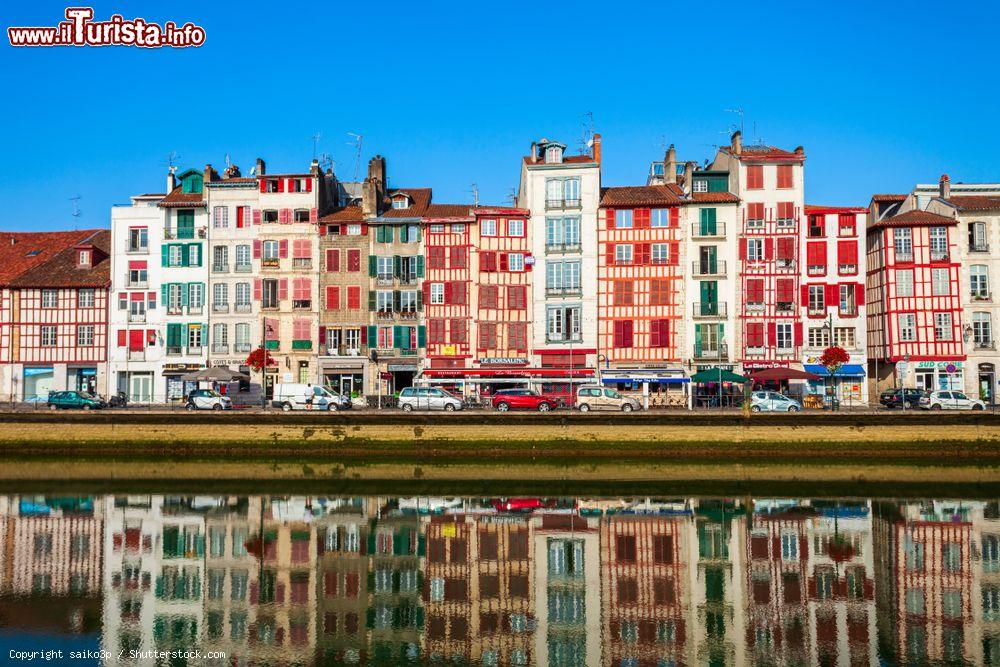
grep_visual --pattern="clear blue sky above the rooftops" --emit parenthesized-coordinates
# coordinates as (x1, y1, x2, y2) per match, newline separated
(0, 0, 1000, 230)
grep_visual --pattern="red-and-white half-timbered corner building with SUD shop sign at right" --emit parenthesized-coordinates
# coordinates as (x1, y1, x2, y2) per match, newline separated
(866, 210, 965, 390)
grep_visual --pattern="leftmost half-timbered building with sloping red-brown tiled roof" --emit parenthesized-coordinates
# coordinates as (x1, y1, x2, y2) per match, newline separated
(0, 230, 111, 402)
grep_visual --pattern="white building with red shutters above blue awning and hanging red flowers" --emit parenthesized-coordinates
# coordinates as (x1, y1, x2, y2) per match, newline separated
(799, 206, 868, 404)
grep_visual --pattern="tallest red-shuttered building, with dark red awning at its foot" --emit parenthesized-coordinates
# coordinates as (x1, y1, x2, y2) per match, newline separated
(710, 132, 805, 373)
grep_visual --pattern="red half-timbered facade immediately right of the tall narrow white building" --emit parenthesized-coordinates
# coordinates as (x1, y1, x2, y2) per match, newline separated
(597, 185, 684, 367)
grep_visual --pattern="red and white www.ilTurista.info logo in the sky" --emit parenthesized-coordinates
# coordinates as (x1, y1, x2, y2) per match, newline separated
(7, 7, 205, 49)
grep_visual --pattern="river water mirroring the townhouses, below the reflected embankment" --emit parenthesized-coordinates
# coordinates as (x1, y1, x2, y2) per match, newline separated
(0, 493, 1000, 667)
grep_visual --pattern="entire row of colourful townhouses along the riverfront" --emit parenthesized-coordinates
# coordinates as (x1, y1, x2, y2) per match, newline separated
(0, 132, 1000, 406)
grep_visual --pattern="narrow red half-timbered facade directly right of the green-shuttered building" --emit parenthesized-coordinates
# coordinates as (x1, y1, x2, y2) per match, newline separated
(423, 204, 476, 368)
